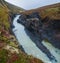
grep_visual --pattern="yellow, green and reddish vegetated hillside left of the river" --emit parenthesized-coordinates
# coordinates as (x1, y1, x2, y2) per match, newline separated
(0, 0, 43, 63)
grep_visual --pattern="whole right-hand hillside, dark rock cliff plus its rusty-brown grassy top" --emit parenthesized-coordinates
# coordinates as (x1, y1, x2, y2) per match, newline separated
(18, 4, 60, 49)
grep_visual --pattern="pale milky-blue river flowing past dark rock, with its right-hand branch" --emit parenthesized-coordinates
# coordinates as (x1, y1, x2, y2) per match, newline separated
(13, 15, 60, 63)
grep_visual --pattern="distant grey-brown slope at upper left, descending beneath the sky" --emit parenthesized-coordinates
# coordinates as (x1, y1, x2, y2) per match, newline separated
(0, 0, 24, 13)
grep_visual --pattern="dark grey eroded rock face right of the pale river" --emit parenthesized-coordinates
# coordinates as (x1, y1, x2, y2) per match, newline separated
(18, 12, 60, 49)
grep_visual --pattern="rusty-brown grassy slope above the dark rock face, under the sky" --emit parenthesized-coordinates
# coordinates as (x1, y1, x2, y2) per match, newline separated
(23, 3, 60, 19)
